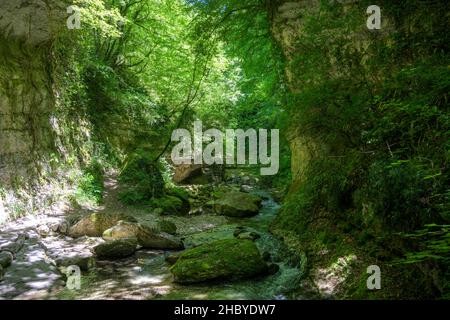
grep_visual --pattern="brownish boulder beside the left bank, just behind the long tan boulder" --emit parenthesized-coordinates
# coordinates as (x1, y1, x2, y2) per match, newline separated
(68, 212, 135, 238)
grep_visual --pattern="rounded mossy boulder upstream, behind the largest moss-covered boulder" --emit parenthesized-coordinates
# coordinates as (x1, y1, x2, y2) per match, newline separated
(213, 190, 262, 218)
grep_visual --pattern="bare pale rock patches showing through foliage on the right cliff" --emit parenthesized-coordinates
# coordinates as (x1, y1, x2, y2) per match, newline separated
(272, 0, 372, 184)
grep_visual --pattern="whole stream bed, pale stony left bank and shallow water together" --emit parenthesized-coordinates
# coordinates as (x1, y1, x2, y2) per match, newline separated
(0, 191, 302, 300)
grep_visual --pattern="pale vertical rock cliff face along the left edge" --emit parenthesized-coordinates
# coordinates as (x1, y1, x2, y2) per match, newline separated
(0, 0, 77, 222)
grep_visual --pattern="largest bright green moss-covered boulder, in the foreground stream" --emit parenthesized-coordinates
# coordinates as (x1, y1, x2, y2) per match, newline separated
(170, 239, 268, 283)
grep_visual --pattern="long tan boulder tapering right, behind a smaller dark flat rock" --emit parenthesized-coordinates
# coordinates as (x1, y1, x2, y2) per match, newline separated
(103, 221, 184, 250)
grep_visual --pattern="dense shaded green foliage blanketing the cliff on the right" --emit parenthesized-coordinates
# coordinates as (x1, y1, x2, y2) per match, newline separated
(275, 1, 450, 294)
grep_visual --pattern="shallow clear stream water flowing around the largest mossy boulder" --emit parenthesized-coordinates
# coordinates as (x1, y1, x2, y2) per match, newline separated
(53, 191, 301, 299)
